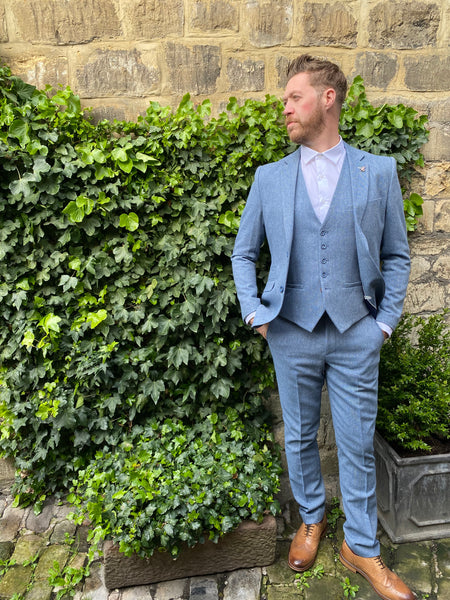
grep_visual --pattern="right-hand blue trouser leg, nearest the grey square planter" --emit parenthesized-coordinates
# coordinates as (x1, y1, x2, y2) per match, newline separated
(326, 316, 384, 557)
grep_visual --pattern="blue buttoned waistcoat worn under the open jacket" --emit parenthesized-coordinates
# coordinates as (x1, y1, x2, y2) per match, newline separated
(280, 157, 368, 333)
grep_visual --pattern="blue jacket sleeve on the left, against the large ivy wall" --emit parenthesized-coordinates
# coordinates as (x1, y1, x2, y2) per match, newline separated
(231, 168, 265, 320)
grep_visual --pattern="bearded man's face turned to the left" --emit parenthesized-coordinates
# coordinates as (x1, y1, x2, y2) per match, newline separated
(283, 73, 325, 146)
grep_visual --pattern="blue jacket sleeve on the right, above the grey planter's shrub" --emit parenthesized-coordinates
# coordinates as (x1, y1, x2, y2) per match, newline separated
(377, 158, 410, 329)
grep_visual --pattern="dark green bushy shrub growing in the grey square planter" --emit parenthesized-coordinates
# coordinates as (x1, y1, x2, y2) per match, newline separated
(377, 311, 450, 451)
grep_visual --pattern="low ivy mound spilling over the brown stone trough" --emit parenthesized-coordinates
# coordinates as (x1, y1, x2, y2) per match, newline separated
(69, 408, 280, 557)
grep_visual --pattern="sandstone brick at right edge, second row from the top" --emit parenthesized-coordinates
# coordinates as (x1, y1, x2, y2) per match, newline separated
(405, 55, 450, 92)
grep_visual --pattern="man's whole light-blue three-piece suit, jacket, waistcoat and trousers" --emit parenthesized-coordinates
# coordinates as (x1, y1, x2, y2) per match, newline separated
(232, 144, 410, 557)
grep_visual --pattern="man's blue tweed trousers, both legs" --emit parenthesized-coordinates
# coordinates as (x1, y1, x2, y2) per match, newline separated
(267, 314, 384, 557)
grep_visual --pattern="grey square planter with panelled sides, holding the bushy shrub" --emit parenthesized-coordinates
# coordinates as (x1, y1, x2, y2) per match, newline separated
(374, 432, 450, 543)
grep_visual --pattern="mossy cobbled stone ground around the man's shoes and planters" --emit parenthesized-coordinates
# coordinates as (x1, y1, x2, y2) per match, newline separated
(0, 482, 450, 600)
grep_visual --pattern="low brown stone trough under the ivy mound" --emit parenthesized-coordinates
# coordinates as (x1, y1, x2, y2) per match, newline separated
(103, 516, 277, 590)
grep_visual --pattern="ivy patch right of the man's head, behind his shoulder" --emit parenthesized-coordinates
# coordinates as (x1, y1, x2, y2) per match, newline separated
(340, 76, 429, 231)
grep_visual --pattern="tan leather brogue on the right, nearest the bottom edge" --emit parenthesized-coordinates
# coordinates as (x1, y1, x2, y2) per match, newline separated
(339, 540, 416, 600)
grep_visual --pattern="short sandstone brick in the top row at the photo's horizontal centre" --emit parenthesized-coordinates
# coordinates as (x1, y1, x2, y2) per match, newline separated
(189, 0, 239, 33)
